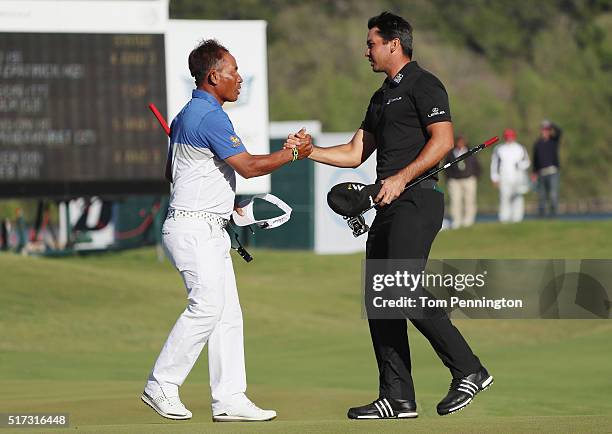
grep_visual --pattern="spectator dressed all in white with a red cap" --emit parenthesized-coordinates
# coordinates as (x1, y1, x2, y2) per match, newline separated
(491, 128, 529, 223)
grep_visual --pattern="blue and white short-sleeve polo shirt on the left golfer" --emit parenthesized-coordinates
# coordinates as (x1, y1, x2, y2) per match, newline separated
(170, 89, 246, 218)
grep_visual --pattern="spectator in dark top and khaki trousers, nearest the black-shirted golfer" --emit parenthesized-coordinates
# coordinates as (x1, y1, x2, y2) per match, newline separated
(445, 136, 480, 229)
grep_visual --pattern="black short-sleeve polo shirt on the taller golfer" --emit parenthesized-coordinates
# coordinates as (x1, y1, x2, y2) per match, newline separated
(361, 61, 451, 180)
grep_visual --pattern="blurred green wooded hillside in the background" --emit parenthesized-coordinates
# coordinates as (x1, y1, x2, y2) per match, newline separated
(170, 0, 612, 208)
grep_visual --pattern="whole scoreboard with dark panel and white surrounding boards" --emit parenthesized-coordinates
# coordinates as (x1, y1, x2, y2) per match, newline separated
(0, 0, 270, 200)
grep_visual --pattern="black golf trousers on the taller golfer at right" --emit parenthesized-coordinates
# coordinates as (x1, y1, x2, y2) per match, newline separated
(366, 187, 482, 400)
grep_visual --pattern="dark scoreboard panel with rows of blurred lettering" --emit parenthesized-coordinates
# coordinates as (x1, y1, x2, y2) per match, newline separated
(0, 32, 168, 197)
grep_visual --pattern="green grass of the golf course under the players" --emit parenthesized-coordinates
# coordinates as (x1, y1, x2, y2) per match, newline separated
(0, 221, 612, 433)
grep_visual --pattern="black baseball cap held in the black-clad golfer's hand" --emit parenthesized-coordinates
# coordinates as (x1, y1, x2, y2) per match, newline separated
(327, 182, 382, 217)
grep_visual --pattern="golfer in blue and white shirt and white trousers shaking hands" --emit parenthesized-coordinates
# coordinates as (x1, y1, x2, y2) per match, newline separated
(142, 40, 312, 421)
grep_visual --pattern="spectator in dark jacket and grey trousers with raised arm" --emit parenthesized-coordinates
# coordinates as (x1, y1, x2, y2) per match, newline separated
(533, 120, 561, 217)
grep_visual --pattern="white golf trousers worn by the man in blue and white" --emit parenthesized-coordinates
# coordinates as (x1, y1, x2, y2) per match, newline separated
(145, 218, 246, 414)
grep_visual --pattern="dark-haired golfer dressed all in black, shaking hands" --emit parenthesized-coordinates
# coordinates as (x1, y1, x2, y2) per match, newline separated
(309, 12, 493, 419)
